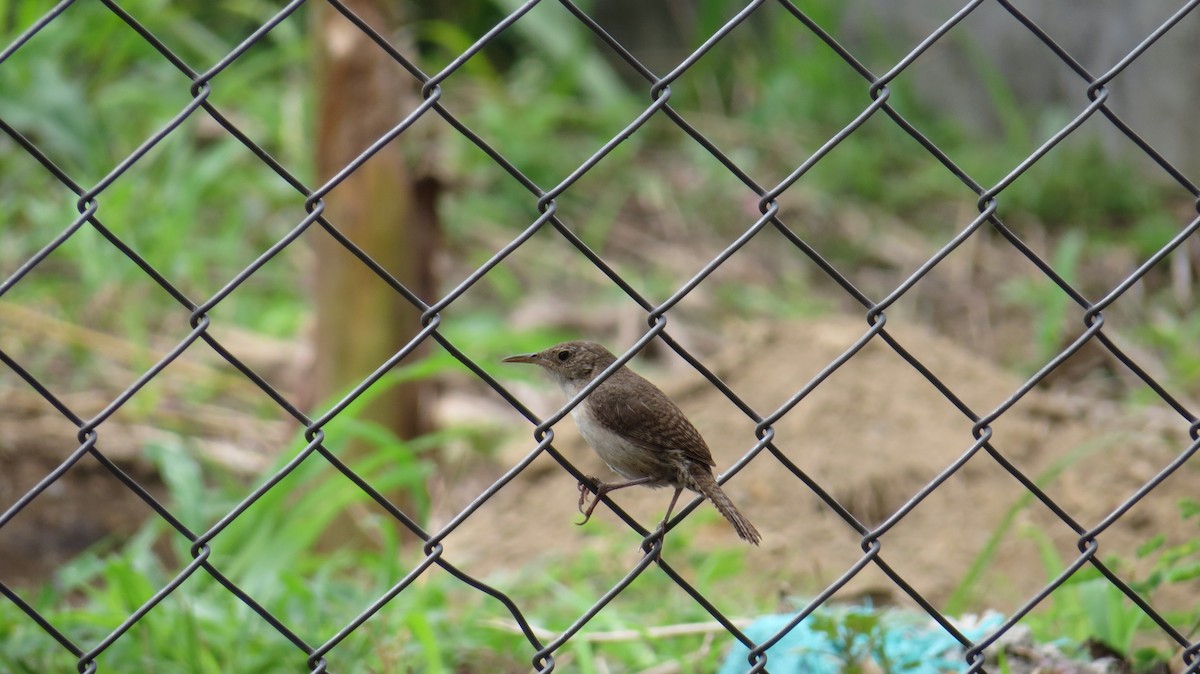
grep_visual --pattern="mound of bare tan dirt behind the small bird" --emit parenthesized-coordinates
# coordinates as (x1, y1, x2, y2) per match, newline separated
(440, 318, 1198, 613)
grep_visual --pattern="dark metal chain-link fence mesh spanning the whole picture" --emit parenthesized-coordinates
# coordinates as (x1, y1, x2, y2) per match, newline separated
(0, 0, 1200, 674)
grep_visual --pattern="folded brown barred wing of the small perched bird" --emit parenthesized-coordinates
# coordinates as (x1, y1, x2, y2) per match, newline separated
(590, 378, 716, 467)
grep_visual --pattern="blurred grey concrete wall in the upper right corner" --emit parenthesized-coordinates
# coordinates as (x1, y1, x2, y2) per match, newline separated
(836, 0, 1200, 180)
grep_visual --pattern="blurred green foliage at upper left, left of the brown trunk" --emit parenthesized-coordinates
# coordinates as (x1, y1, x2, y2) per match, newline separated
(0, 0, 312, 336)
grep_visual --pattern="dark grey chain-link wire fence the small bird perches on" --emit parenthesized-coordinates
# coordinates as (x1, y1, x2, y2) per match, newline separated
(0, 0, 1200, 673)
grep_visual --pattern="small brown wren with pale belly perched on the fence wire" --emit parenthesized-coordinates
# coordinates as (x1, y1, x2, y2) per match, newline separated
(504, 342, 761, 544)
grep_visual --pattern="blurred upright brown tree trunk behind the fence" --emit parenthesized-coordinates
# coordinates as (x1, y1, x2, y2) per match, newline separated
(312, 0, 436, 536)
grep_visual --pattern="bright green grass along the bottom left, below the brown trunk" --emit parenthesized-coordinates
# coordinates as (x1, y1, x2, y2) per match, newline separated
(0, 425, 755, 673)
